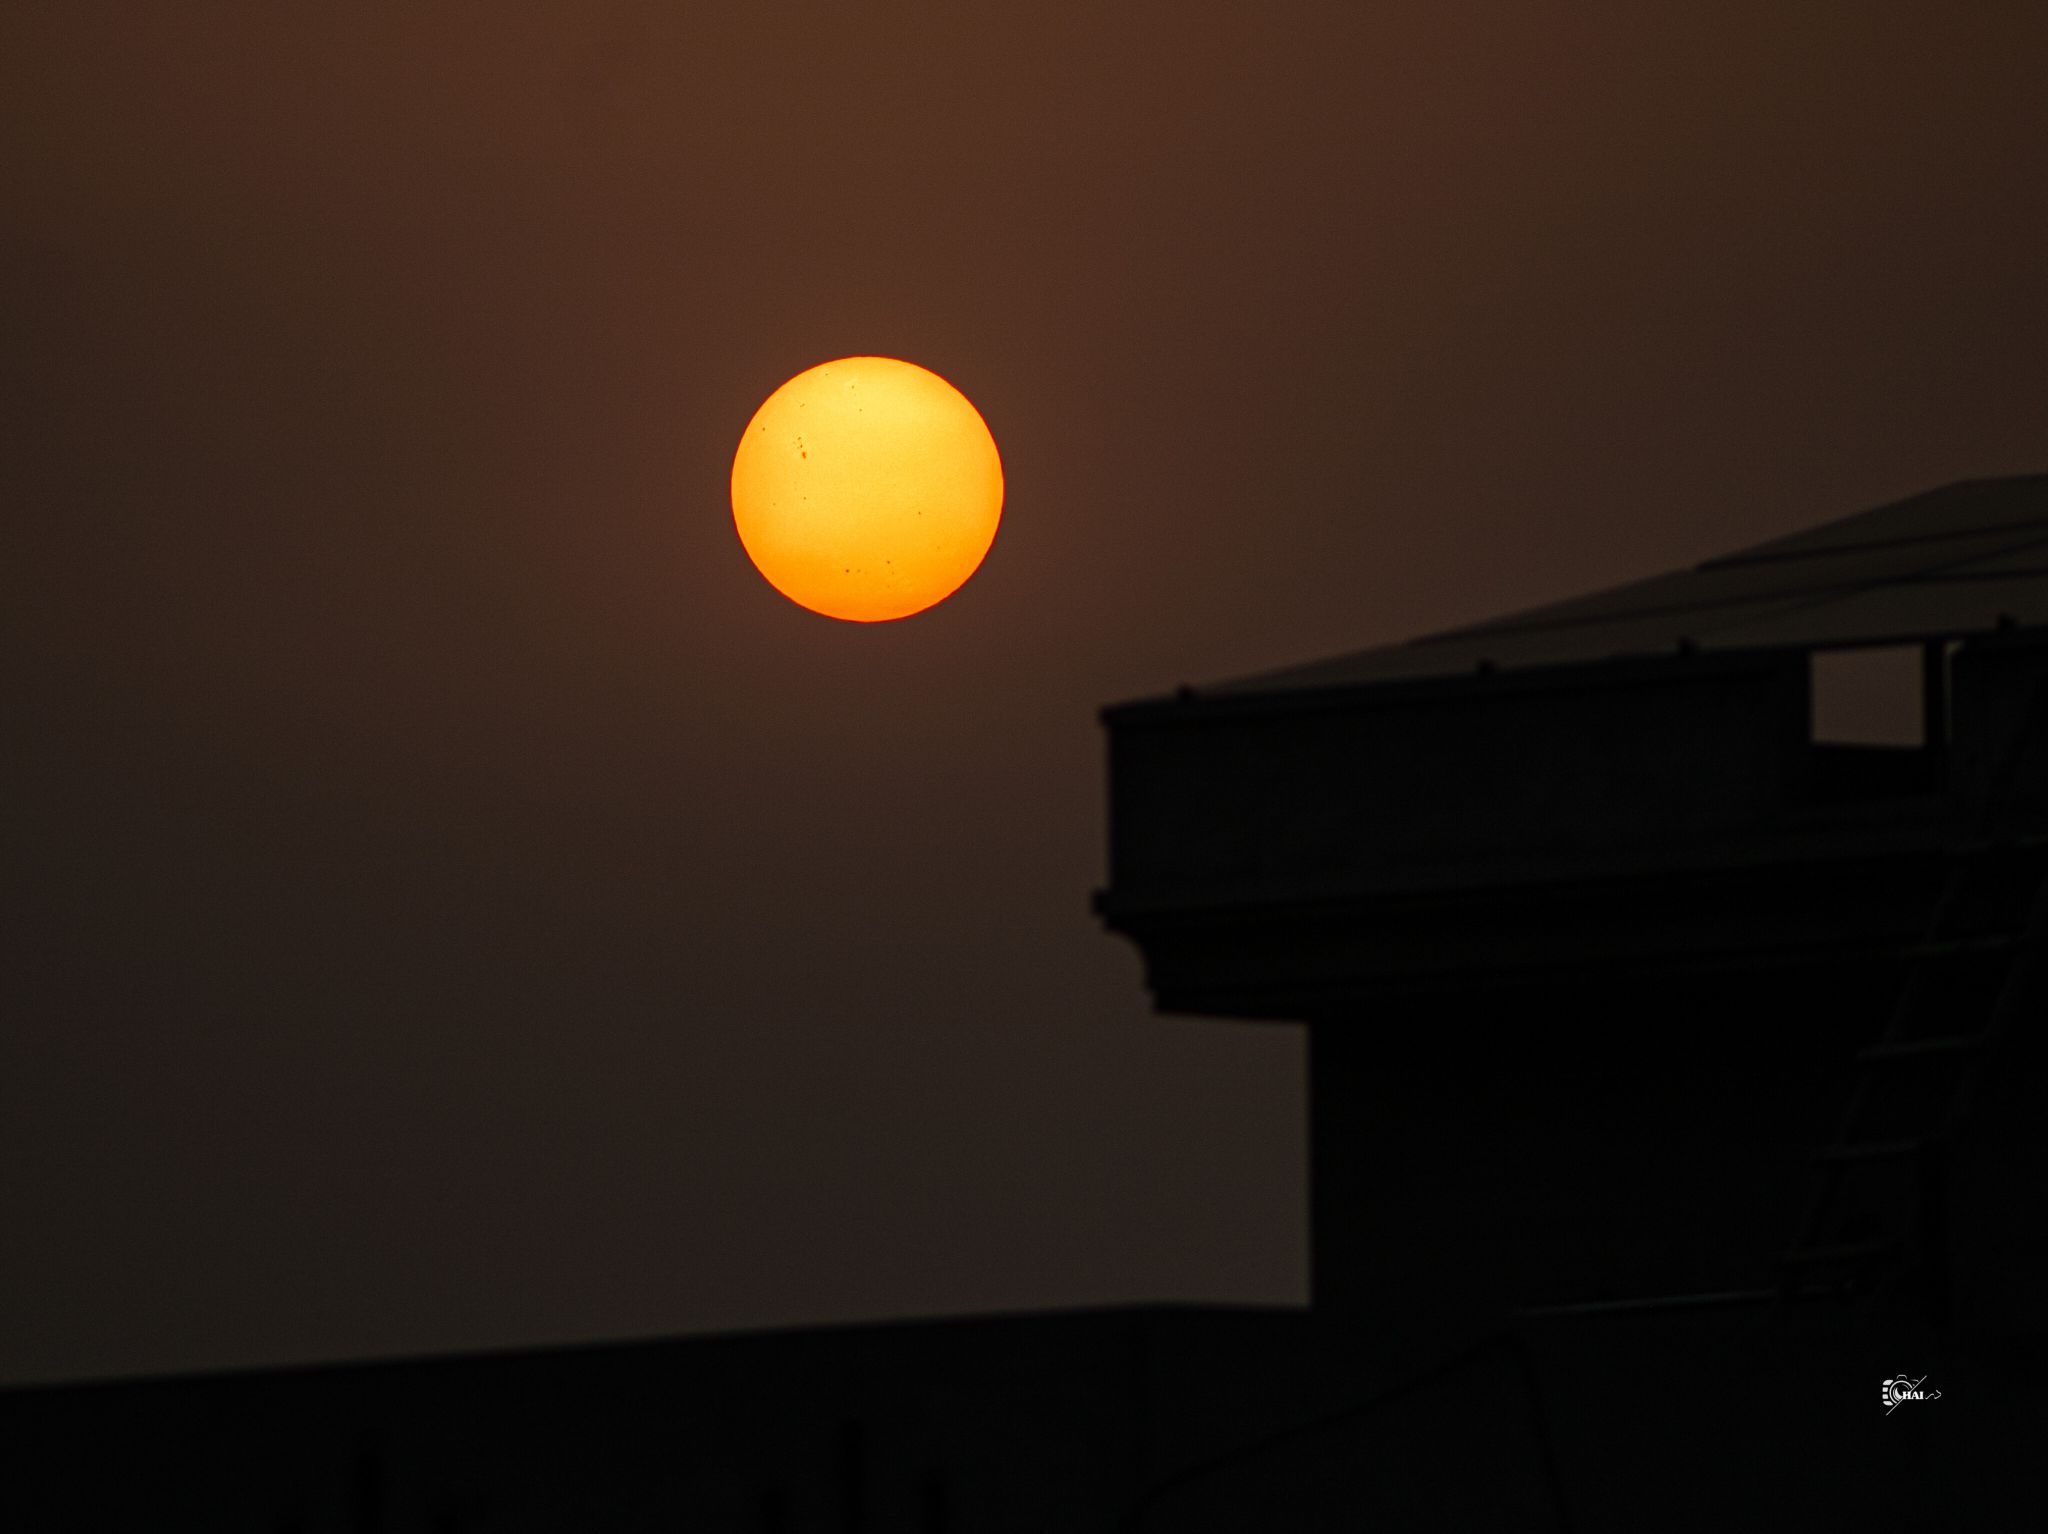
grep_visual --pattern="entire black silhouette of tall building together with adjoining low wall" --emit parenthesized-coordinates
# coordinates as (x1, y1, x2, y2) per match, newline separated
(0, 477, 2048, 1532)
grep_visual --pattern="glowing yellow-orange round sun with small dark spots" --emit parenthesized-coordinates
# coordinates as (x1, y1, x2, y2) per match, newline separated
(733, 356, 1004, 623)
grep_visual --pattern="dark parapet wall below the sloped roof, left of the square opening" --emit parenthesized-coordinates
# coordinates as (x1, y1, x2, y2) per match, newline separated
(1110, 653, 1808, 895)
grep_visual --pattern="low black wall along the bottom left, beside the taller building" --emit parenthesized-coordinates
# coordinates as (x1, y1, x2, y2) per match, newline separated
(0, 1307, 1307, 1534)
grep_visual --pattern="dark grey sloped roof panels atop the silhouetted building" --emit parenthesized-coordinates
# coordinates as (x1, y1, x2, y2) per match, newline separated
(1196, 475, 2048, 694)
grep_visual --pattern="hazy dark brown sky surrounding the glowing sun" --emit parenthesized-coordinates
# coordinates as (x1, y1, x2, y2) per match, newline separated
(0, 0, 2048, 1380)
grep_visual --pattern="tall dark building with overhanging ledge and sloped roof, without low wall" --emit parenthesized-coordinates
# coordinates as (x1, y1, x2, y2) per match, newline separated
(1100, 477, 2048, 1528)
